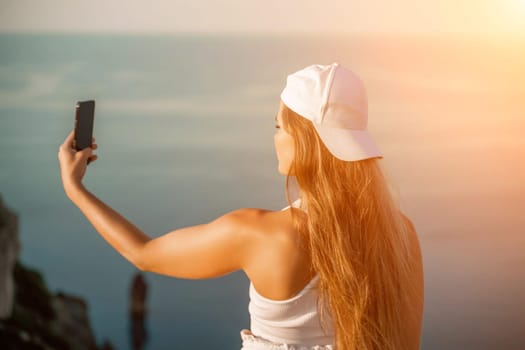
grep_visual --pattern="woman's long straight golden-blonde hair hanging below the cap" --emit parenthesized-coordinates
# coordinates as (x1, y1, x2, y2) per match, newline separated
(283, 105, 415, 350)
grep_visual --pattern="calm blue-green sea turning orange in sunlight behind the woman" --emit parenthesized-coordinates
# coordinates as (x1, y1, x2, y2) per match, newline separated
(0, 34, 525, 349)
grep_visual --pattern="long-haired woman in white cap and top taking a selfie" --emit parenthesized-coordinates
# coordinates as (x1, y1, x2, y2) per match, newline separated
(58, 62, 423, 350)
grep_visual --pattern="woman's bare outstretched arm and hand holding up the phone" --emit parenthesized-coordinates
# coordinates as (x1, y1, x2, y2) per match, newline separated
(58, 132, 263, 279)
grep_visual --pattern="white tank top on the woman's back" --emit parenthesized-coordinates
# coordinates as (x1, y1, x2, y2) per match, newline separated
(248, 200, 335, 348)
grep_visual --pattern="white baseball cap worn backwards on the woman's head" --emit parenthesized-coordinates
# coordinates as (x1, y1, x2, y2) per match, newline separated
(281, 62, 383, 161)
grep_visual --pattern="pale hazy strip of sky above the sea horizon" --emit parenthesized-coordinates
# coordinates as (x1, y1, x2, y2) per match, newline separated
(0, 0, 525, 34)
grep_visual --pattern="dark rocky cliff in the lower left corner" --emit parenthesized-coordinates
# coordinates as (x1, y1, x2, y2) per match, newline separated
(0, 196, 113, 350)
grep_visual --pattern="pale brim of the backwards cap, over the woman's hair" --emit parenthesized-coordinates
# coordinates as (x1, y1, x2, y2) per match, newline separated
(312, 123, 383, 161)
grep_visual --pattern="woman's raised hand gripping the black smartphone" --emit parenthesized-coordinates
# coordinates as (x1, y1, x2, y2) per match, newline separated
(58, 131, 98, 196)
